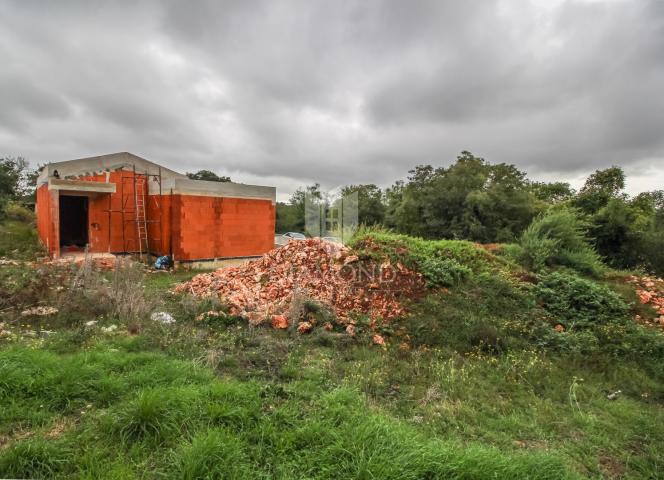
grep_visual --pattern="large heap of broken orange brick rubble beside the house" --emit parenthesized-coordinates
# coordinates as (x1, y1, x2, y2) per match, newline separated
(176, 239, 425, 333)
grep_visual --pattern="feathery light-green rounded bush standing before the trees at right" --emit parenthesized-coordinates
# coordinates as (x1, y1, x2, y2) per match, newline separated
(519, 208, 604, 275)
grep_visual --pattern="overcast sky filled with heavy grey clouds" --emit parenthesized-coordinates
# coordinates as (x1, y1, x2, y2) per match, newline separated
(0, 0, 664, 199)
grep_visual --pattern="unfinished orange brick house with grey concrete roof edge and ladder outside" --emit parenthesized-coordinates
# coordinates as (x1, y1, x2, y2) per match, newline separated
(36, 152, 276, 263)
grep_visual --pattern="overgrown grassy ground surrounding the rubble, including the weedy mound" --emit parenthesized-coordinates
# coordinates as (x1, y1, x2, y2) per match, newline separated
(0, 220, 664, 479)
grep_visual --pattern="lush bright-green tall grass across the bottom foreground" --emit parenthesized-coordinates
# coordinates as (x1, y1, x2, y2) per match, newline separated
(0, 349, 574, 479)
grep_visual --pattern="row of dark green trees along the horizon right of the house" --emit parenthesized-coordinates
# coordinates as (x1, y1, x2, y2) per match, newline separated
(277, 151, 664, 274)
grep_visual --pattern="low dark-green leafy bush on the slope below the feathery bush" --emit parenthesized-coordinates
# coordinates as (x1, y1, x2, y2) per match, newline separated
(535, 272, 629, 331)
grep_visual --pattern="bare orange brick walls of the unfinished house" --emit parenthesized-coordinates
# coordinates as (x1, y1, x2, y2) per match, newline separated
(37, 171, 275, 261)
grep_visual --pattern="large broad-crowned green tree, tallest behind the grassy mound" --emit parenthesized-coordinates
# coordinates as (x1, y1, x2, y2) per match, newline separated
(390, 151, 539, 242)
